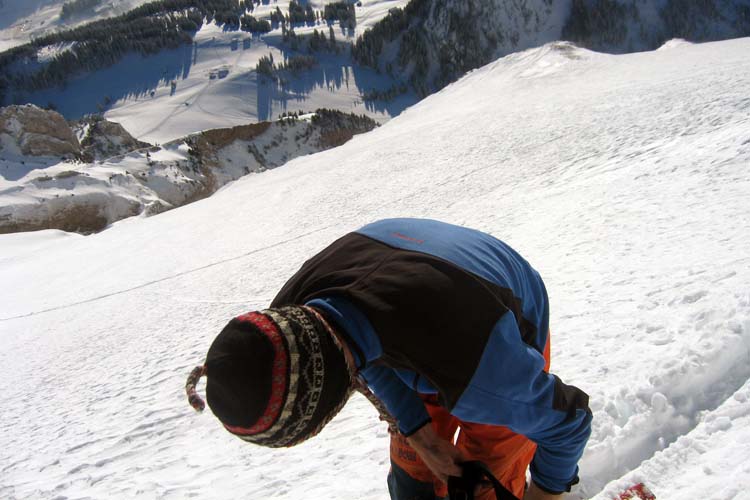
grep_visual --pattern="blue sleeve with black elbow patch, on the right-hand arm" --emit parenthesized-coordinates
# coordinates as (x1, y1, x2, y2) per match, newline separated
(452, 313, 591, 492)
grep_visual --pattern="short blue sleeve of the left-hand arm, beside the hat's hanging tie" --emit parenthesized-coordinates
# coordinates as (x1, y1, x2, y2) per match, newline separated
(360, 365, 430, 436)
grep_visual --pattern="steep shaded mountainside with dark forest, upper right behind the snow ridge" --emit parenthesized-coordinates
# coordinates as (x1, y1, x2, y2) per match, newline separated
(353, 0, 750, 95)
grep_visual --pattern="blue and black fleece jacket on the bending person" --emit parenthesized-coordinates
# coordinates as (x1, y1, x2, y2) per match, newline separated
(271, 219, 591, 493)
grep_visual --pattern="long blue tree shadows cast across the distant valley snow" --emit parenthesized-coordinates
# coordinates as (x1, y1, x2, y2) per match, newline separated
(8, 27, 419, 125)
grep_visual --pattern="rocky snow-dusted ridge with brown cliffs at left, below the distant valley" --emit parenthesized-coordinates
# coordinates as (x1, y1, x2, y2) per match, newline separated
(0, 105, 377, 233)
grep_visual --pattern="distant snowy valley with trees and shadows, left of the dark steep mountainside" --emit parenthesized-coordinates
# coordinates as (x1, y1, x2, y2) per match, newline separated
(0, 0, 416, 143)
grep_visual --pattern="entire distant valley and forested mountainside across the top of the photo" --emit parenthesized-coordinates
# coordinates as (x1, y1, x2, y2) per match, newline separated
(0, 0, 750, 148)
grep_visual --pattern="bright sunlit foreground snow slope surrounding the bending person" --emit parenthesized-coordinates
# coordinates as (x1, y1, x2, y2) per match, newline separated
(0, 39, 750, 500)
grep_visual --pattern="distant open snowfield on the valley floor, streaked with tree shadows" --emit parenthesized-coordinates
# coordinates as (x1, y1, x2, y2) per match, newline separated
(5, 0, 417, 143)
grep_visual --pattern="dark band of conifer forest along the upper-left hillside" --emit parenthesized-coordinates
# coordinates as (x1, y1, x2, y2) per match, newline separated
(0, 0, 364, 104)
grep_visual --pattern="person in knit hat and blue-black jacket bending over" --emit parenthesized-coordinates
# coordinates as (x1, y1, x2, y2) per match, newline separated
(188, 219, 592, 500)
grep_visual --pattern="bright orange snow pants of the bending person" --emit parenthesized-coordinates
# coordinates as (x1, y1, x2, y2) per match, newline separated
(389, 335, 550, 500)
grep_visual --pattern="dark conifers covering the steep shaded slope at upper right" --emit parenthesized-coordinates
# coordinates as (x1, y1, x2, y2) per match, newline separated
(352, 0, 750, 95)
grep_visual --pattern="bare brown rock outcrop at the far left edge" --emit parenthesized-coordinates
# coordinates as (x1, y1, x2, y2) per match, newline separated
(0, 104, 82, 159)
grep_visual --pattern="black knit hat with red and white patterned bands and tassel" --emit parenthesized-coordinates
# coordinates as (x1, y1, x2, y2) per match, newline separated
(187, 306, 352, 448)
